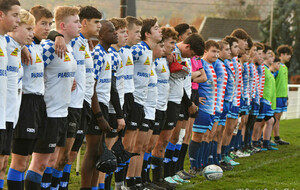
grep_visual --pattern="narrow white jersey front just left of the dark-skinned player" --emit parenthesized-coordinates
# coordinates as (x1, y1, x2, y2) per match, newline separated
(84, 44, 95, 105)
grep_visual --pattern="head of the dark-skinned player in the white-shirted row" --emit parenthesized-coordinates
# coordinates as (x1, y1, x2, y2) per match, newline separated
(98, 20, 118, 46)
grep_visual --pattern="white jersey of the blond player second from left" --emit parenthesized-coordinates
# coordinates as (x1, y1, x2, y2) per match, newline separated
(5, 35, 21, 123)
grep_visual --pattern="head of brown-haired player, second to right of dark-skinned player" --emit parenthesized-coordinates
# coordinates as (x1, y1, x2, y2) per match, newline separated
(125, 16, 143, 46)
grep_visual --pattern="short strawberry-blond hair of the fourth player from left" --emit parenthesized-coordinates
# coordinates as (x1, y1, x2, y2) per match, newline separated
(54, 6, 80, 27)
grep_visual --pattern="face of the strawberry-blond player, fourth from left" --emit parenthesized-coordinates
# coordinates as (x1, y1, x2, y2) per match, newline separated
(65, 15, 81, 38)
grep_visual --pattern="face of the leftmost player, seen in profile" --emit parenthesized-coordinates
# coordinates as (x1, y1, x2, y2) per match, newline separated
(0, 5, 21, 33)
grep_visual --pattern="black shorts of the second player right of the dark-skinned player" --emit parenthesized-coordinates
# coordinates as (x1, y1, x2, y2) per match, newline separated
(127, 102, 145, 131)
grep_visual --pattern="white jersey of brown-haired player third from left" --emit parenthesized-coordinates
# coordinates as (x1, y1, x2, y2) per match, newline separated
(22, 39, 45, 95)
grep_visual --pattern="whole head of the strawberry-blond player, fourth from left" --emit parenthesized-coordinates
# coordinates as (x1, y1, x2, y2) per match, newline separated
(54, 6, 81, 40)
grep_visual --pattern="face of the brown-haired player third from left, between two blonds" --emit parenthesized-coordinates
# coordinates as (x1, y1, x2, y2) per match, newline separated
(33, 17, 53, 40)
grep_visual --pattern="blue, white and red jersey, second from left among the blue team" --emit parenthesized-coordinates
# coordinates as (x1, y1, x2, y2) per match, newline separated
(212, 59, 228, 113)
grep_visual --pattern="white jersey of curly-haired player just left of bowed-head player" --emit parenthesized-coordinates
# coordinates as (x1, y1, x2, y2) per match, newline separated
(154, 58, 170, 111)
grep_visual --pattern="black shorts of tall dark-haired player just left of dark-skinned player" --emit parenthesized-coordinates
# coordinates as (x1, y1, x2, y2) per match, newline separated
(72, 100, 92, 152)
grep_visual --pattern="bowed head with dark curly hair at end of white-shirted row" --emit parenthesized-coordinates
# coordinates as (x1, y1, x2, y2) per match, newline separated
(180, 34, 205, 58)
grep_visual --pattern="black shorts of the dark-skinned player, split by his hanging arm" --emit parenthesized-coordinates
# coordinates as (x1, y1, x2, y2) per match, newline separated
(86, 102, 109, 135)
